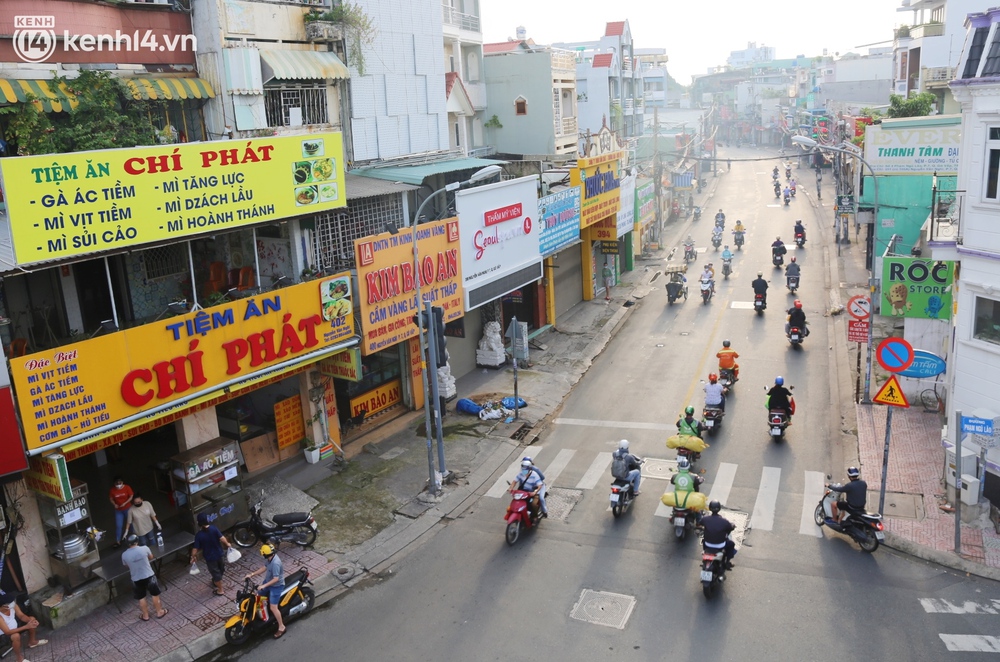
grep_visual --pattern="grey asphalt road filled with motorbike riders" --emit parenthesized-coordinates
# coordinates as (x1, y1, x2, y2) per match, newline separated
(227, 149, 1000, 662)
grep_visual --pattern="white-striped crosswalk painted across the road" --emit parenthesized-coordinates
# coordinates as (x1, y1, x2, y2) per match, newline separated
(485, 446, 825, 538)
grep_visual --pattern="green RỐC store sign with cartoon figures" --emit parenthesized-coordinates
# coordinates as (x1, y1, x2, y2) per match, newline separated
(882, 257, 955, 319)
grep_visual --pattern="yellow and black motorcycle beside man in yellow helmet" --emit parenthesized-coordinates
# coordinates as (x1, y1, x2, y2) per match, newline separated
(226, 568, 316, 646)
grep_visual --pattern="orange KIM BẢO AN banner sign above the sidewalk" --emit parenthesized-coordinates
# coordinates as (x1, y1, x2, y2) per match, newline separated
(354, 218, 465, 356)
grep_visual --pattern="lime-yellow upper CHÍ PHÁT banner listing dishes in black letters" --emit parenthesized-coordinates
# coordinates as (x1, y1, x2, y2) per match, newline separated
(0, 133, 347, 265)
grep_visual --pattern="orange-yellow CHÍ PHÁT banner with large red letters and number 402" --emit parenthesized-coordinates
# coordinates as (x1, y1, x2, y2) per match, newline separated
(11, 272, 354, 450)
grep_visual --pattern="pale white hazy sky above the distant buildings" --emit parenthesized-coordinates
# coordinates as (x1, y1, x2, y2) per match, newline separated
(479, 0, 908, 85)
